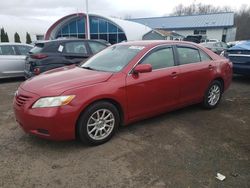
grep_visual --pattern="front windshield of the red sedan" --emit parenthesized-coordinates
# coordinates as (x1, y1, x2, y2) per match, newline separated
(81, 45, 144, 72)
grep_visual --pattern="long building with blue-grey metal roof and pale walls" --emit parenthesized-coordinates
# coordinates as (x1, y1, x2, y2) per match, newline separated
(129, 12, 236, 42)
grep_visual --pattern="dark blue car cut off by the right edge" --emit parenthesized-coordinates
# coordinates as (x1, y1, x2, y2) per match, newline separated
(225, 40, 250, 76)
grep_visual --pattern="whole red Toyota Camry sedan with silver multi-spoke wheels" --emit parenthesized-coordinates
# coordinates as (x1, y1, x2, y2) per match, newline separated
(14, 41, 232, 145)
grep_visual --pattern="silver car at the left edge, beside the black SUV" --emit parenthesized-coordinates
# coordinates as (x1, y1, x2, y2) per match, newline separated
(0, 43, 33, 78)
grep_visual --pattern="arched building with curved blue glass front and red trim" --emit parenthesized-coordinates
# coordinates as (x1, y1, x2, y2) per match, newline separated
(45, 13, 152, 44)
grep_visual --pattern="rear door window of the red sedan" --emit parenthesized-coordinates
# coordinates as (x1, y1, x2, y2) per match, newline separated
(177, 47, 200, 65)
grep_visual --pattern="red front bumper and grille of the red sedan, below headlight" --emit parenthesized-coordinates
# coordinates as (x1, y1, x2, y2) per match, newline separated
(13, 88, 76, 140)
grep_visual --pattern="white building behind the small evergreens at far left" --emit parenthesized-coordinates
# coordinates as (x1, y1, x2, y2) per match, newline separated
(0, 15, 52, 43)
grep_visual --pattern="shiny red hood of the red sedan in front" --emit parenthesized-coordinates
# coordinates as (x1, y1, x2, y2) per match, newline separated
(20, 66, 112, 96)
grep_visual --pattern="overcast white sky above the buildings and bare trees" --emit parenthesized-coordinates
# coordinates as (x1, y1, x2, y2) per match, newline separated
(0, 0, 250, 19)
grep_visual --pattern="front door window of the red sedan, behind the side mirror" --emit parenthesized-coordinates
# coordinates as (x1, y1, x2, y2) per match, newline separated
(142, 48, 174, 70)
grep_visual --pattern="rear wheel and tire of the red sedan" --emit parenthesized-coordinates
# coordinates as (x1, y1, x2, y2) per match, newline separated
(203, 80, 222, 109)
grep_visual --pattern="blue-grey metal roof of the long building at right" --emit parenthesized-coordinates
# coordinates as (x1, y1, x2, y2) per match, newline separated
(129, 12, 234, 30)
